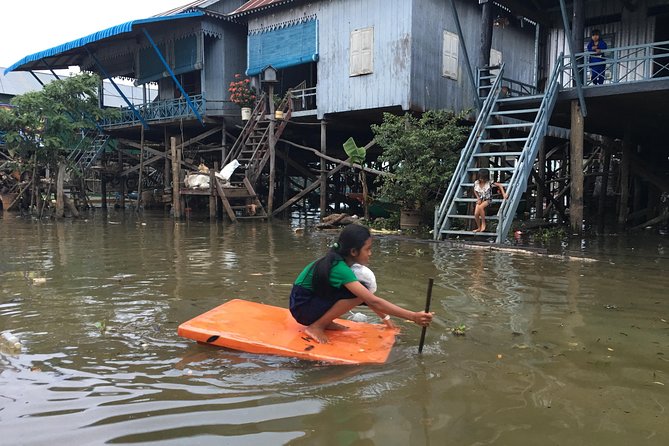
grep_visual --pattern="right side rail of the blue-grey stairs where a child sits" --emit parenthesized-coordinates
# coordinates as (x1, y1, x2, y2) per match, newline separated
(496, 54, 564, 243)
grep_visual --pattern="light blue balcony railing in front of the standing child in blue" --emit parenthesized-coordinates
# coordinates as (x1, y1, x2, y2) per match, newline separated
(560, 41, 669, 88)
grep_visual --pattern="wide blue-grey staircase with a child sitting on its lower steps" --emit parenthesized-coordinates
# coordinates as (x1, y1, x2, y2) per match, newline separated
(434, 55, 562, 243)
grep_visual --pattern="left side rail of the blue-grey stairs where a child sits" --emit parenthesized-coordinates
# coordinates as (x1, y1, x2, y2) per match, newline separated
(433, 64, 504, 240)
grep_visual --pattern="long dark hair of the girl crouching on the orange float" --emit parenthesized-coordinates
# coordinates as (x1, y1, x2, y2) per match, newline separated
(312, 224, 372, 297)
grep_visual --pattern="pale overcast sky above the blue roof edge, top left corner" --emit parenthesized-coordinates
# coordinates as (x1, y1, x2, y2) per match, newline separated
(0, 0, 190, 67)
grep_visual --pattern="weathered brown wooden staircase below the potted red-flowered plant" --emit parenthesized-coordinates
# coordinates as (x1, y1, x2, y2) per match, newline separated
(216, 90, 292, 221)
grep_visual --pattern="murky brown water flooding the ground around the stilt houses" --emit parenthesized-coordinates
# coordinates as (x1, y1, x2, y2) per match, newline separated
(0, 211, 669, 446)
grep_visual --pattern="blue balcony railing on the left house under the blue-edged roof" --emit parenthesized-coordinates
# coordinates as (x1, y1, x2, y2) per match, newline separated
(102, 95, 207, 127)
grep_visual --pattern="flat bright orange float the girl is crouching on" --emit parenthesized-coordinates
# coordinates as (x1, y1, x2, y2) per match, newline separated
(177, 299, 398, 364)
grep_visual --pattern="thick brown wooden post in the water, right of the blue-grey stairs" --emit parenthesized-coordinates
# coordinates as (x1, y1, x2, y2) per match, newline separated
(569, 101, 583, 233)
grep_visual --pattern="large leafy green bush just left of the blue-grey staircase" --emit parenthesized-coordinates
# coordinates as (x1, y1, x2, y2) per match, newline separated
(372, 110, 469, 228)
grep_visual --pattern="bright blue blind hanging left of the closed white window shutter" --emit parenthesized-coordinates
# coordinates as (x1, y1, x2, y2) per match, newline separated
(246, 19, 318, 76)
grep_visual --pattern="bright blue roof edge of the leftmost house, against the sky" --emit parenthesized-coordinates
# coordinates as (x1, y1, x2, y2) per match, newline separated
(5, 11, 204, 74)
